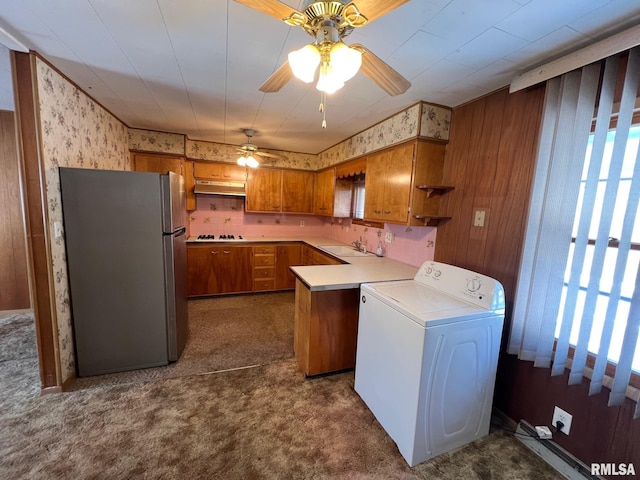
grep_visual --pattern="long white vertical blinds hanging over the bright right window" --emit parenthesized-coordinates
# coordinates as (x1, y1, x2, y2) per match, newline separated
(508, 48, 640, 418)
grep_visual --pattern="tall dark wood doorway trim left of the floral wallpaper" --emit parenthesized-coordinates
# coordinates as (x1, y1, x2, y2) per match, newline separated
(11, 51, 62, 392)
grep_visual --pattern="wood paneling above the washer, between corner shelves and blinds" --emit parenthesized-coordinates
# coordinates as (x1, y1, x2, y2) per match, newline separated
(435, 88, 544, 302)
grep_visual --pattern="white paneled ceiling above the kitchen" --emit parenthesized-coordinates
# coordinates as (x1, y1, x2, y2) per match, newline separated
(0, 0, 640, 153)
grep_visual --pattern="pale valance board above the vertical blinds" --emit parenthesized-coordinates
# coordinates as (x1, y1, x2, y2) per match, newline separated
(509, 25, 640, 93)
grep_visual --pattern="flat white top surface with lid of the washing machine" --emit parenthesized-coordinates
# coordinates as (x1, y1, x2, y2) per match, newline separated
(363, 280, 496, 327)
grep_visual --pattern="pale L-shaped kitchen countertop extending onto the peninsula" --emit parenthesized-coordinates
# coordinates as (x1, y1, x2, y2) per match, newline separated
(189, 236, 418, 291)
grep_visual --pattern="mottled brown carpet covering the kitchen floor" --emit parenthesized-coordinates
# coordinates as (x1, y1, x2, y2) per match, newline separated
(0, 293, 562, 480)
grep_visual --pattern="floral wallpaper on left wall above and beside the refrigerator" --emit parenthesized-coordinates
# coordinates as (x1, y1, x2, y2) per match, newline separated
(37, 58, 130, 381)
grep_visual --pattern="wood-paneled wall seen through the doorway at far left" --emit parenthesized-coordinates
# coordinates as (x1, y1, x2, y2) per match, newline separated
(0, 110, 31, 311)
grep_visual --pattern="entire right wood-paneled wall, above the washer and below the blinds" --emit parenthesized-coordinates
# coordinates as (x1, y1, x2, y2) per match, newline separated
(434, 87, 640, 469)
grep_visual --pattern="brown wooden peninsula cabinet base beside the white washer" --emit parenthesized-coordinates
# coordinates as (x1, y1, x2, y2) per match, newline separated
(293, 279, 360, 376)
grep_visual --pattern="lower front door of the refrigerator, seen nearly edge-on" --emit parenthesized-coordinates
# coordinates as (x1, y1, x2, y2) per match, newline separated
(164, 228, 189, 362)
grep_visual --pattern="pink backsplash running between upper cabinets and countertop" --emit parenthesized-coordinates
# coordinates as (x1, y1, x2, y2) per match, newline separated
(189, 195, 436, 267)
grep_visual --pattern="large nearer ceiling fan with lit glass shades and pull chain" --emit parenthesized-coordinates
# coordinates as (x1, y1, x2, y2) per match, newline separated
(235, 0, 411, 128)
